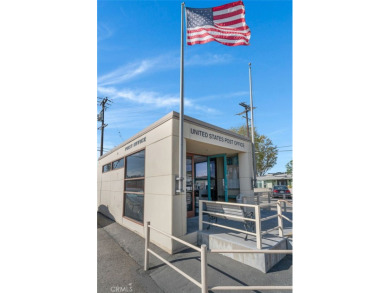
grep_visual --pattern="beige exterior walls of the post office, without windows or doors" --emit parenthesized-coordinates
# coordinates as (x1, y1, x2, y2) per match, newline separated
(97, 113, 253, 253)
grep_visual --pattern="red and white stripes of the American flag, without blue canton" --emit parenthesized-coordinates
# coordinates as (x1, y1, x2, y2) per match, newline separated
(187, 1, 251, 46)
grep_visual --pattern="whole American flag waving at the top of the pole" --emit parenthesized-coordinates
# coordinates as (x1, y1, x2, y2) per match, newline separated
(186, 1, 251, 46)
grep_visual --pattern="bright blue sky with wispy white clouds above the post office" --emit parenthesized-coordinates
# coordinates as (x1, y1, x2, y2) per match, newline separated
(97, 1, 292, 172)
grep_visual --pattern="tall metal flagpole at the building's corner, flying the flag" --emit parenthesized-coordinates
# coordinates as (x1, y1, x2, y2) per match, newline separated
(176, 2, 184, 193)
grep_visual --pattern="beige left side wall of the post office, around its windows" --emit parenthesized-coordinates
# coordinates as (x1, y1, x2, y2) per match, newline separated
(98, 116, 174, 252)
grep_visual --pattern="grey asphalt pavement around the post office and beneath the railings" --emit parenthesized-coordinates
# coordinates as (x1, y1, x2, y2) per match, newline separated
(98, 213, 292, 293)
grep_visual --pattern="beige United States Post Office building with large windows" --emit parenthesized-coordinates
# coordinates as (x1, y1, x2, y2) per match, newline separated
(97, 112, 253, 253)
